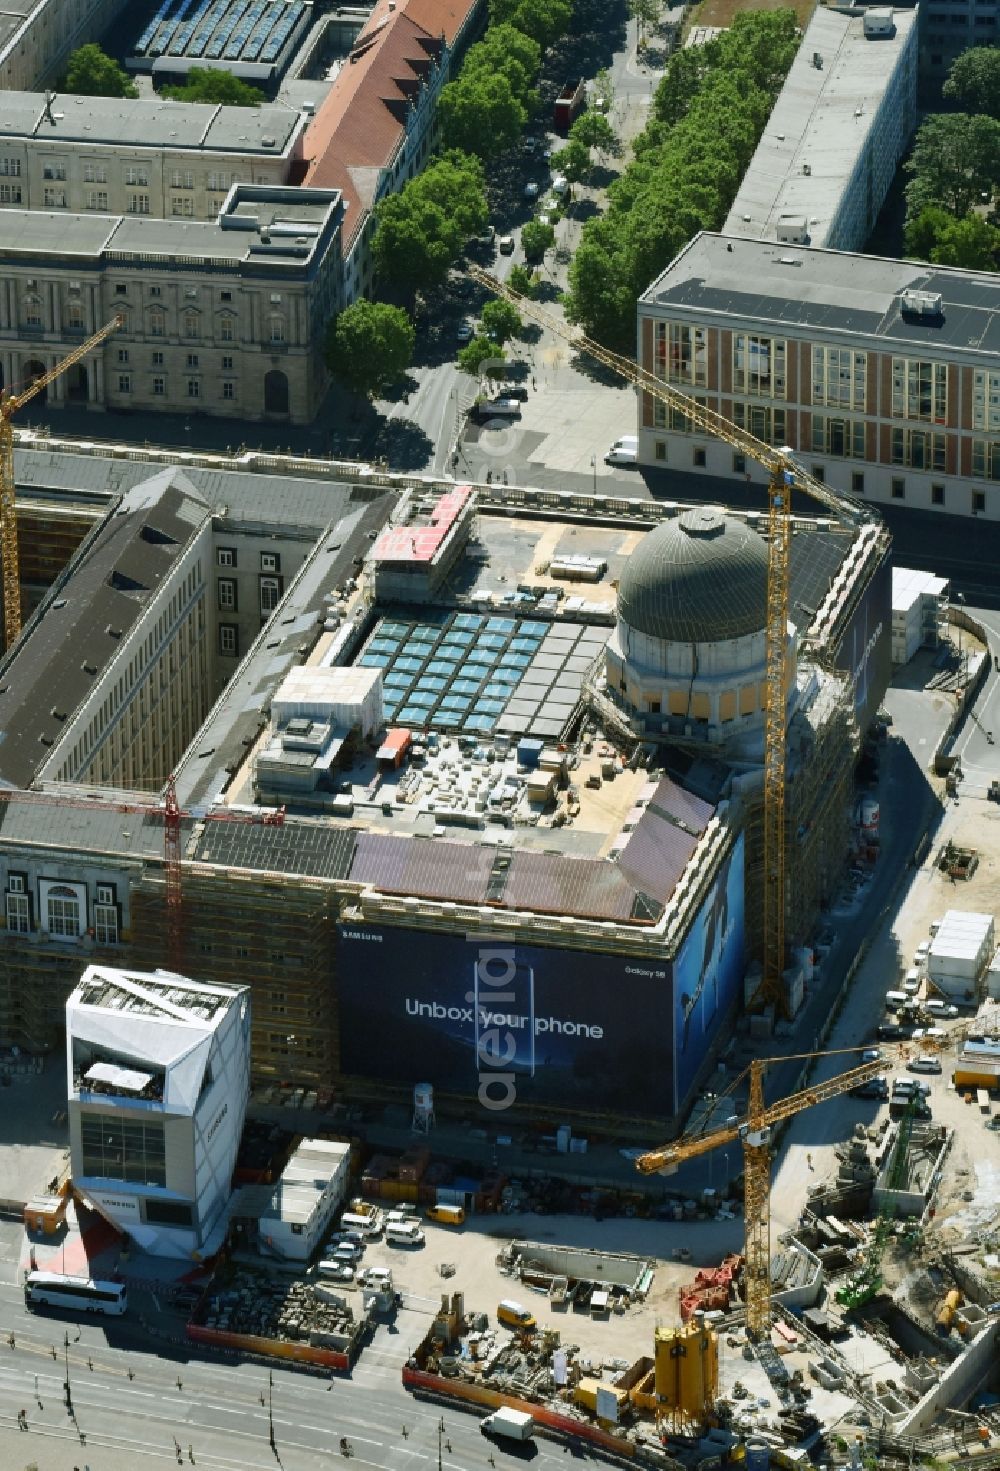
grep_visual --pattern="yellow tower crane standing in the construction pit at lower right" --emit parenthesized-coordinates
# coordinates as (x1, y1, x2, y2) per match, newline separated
(635, 1049, 885, 1340)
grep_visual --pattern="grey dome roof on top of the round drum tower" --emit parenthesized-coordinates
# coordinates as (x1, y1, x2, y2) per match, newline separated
(618, 506, 768, 643)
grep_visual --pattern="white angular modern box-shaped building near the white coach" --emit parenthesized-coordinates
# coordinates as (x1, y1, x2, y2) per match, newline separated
(66, 965, 250, 1259)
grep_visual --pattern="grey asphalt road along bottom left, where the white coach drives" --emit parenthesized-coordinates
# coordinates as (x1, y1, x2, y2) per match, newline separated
(0, 1265, 565, 1471)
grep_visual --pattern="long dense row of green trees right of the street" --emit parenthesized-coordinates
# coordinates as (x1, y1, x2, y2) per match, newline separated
(567, 9, 799, 350)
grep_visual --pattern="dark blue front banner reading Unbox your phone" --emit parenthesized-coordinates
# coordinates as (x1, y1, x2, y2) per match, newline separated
(337, 924, 674, 1116)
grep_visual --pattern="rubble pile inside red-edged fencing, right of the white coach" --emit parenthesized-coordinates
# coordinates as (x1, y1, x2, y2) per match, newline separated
(194, 1269, 365, 1352)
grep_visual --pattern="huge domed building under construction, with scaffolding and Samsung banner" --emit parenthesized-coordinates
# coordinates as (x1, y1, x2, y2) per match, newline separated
(0, 447, 891, 1128)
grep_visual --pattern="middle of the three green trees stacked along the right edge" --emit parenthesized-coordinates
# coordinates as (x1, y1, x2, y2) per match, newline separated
(904, 112, 1000, 219)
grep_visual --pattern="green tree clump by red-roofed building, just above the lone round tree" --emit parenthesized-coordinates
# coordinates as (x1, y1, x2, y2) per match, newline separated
(372, 150, 490, 291)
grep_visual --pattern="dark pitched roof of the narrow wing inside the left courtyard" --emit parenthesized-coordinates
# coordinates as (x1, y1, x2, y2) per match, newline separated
(0, 469, 209, 787)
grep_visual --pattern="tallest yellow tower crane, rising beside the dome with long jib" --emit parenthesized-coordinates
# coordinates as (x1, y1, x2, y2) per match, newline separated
(466, 266, 875, 1015)
